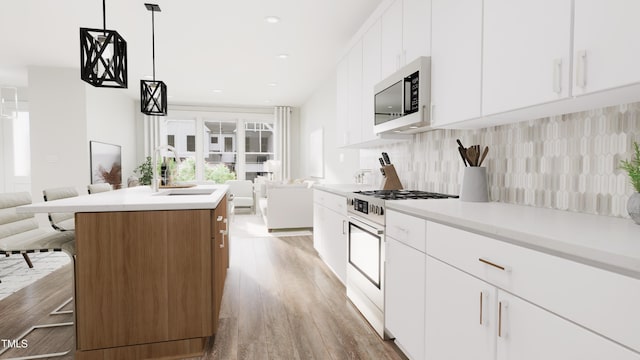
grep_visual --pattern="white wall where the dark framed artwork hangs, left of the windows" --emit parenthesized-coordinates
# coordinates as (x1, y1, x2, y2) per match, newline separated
(85, 87, 140, 187)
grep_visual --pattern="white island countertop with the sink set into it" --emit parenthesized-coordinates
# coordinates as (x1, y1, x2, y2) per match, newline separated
(18, 185, 229, 213)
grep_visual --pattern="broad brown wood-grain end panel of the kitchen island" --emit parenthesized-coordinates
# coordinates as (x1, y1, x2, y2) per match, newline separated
(75, 210, 212, 351)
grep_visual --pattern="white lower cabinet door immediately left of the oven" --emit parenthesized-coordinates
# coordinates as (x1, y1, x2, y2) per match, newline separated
(322, 208, 348, 284)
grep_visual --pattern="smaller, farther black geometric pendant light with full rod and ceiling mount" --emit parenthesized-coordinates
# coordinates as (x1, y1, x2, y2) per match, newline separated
(140, 4, 167, 116)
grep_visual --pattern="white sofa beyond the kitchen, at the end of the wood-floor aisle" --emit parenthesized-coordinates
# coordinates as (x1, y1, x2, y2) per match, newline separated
(258, 183, 313, 232)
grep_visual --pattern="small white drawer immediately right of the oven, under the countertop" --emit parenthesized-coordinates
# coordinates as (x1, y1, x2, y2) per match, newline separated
(386, 210, 427, 252)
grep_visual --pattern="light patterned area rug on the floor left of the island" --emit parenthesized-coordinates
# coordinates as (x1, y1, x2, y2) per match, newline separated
(0, 252, 71, 300)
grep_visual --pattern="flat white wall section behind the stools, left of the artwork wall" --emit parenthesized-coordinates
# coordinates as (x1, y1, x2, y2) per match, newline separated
(29, 67, 91, 202)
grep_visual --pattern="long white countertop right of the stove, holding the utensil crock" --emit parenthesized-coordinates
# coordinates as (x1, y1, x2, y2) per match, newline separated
(385, 199, 640, 279)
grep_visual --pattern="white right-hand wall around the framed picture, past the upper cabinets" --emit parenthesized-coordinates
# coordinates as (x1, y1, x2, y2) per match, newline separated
(292, 71, 359, 184)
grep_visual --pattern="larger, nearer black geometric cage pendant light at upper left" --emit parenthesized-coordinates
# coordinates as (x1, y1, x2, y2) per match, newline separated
(80, 0, 127, 89)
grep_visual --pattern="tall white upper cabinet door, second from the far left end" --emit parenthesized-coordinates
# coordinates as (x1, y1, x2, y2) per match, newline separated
(348, 41, 362, 144)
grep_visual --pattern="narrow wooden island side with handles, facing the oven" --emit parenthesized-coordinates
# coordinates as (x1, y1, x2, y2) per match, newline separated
(211, 194, 229, 334)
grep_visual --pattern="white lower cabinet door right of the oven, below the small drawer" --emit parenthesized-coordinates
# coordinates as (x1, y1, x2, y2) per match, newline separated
(384, 237, 426, 359)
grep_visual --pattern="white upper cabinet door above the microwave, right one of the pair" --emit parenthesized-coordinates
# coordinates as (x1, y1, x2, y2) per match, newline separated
(402, 0, 431, 65)
